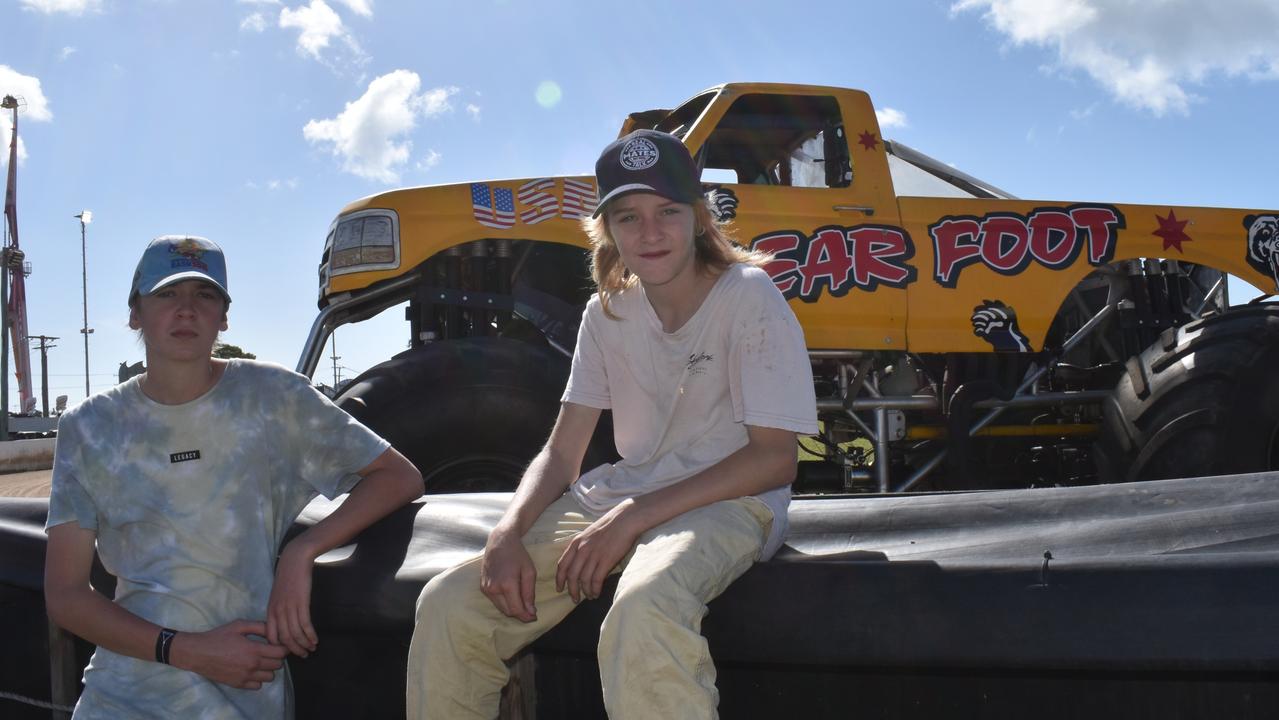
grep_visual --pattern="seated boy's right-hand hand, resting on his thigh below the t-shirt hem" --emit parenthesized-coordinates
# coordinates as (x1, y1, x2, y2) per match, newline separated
(555, 500, 643, 602)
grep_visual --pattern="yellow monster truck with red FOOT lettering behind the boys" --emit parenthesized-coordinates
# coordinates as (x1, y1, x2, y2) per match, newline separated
(298, 83, 1279, 492)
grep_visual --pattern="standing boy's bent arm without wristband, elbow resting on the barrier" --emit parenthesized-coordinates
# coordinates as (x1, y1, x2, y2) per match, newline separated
(265, 448, 422, 657)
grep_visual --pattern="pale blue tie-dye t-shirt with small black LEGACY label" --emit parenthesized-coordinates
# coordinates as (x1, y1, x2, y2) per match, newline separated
(46, 361, 389, 720)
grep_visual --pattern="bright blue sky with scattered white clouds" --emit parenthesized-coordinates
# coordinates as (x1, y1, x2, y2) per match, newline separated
(0, 0, 1279, 408)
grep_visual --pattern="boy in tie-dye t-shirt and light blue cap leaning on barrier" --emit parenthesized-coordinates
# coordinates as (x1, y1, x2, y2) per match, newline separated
(45, 235, 422, 720)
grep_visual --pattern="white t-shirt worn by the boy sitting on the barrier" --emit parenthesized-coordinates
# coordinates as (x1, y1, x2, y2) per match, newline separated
(561, 263, 817, 559)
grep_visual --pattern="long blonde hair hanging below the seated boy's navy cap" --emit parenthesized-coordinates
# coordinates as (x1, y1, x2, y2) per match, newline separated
(582, 198, 771, 320)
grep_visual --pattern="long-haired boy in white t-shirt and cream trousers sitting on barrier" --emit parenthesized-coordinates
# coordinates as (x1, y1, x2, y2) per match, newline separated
(408, 130, 817, 720)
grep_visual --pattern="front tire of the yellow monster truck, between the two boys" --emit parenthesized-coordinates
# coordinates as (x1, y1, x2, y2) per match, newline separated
(335, 338, 614, 492)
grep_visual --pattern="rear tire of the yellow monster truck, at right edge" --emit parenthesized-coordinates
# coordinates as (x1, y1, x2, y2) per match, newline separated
(1099, 304, 1279, 482)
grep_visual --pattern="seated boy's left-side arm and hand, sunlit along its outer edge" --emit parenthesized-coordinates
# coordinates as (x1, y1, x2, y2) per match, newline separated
(480, 403, 600, 623)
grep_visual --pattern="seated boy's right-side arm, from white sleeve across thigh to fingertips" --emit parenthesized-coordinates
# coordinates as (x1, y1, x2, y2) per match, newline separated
(555, 425, 796, 602)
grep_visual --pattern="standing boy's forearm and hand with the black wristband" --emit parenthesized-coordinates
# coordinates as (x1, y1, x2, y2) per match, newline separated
(45, 522, 288, 689)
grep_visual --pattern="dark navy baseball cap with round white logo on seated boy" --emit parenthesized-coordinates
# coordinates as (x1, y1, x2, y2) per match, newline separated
(592, 130, 702, 217)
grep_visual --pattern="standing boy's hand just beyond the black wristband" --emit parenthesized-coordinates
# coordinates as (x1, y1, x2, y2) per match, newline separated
(169, 620, 289, 691)
